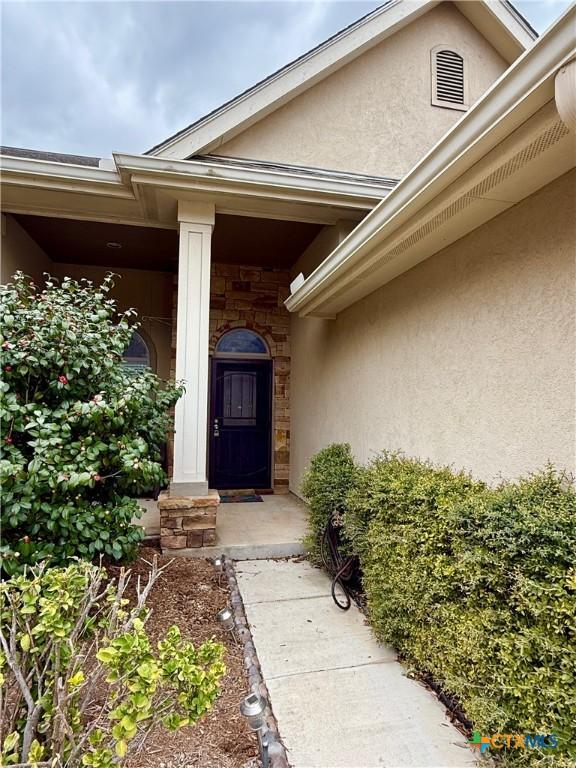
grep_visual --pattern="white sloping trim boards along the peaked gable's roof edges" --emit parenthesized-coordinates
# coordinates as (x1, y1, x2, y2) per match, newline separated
(146, 0, 536, 159)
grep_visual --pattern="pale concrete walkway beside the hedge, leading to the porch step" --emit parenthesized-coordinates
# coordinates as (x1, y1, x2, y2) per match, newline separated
(236, 560, 475, 768)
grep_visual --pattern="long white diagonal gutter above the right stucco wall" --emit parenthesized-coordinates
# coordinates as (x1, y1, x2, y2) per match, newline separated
(285, 5, 576, 312)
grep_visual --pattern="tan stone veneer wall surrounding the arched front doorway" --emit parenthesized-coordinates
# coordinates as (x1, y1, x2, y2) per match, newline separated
(168, 263, 290, 493)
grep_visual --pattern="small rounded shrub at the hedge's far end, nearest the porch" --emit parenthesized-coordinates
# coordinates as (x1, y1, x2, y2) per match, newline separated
(301, 443, 357, 563)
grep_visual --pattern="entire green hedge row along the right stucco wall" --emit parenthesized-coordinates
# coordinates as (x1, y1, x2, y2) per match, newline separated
(303, 445, 576, 765)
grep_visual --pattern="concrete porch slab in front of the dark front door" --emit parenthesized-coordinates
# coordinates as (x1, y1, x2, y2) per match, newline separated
(135, 493, 306, 560)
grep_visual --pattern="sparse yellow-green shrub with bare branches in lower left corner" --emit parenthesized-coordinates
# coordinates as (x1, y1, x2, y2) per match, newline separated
(0, 559, 225, 768)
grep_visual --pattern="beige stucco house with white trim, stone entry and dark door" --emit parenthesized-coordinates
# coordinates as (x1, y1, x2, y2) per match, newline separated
(2, 0, 576, 551)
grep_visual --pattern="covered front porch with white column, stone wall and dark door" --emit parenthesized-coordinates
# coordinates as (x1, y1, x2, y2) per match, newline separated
(3, 150, 391, 557)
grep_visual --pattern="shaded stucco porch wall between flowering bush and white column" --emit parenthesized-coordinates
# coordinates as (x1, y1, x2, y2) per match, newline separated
(51, 263, 172, 379)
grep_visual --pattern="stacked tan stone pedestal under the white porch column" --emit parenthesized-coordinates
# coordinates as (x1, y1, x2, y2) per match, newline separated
(158, 490, 220, 555)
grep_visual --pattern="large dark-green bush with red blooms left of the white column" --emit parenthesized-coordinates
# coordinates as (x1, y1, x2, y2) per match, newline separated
(0, 272, 182, 573)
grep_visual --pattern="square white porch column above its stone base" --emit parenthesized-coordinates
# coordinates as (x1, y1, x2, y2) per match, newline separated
(170, 201, 214, 496)
